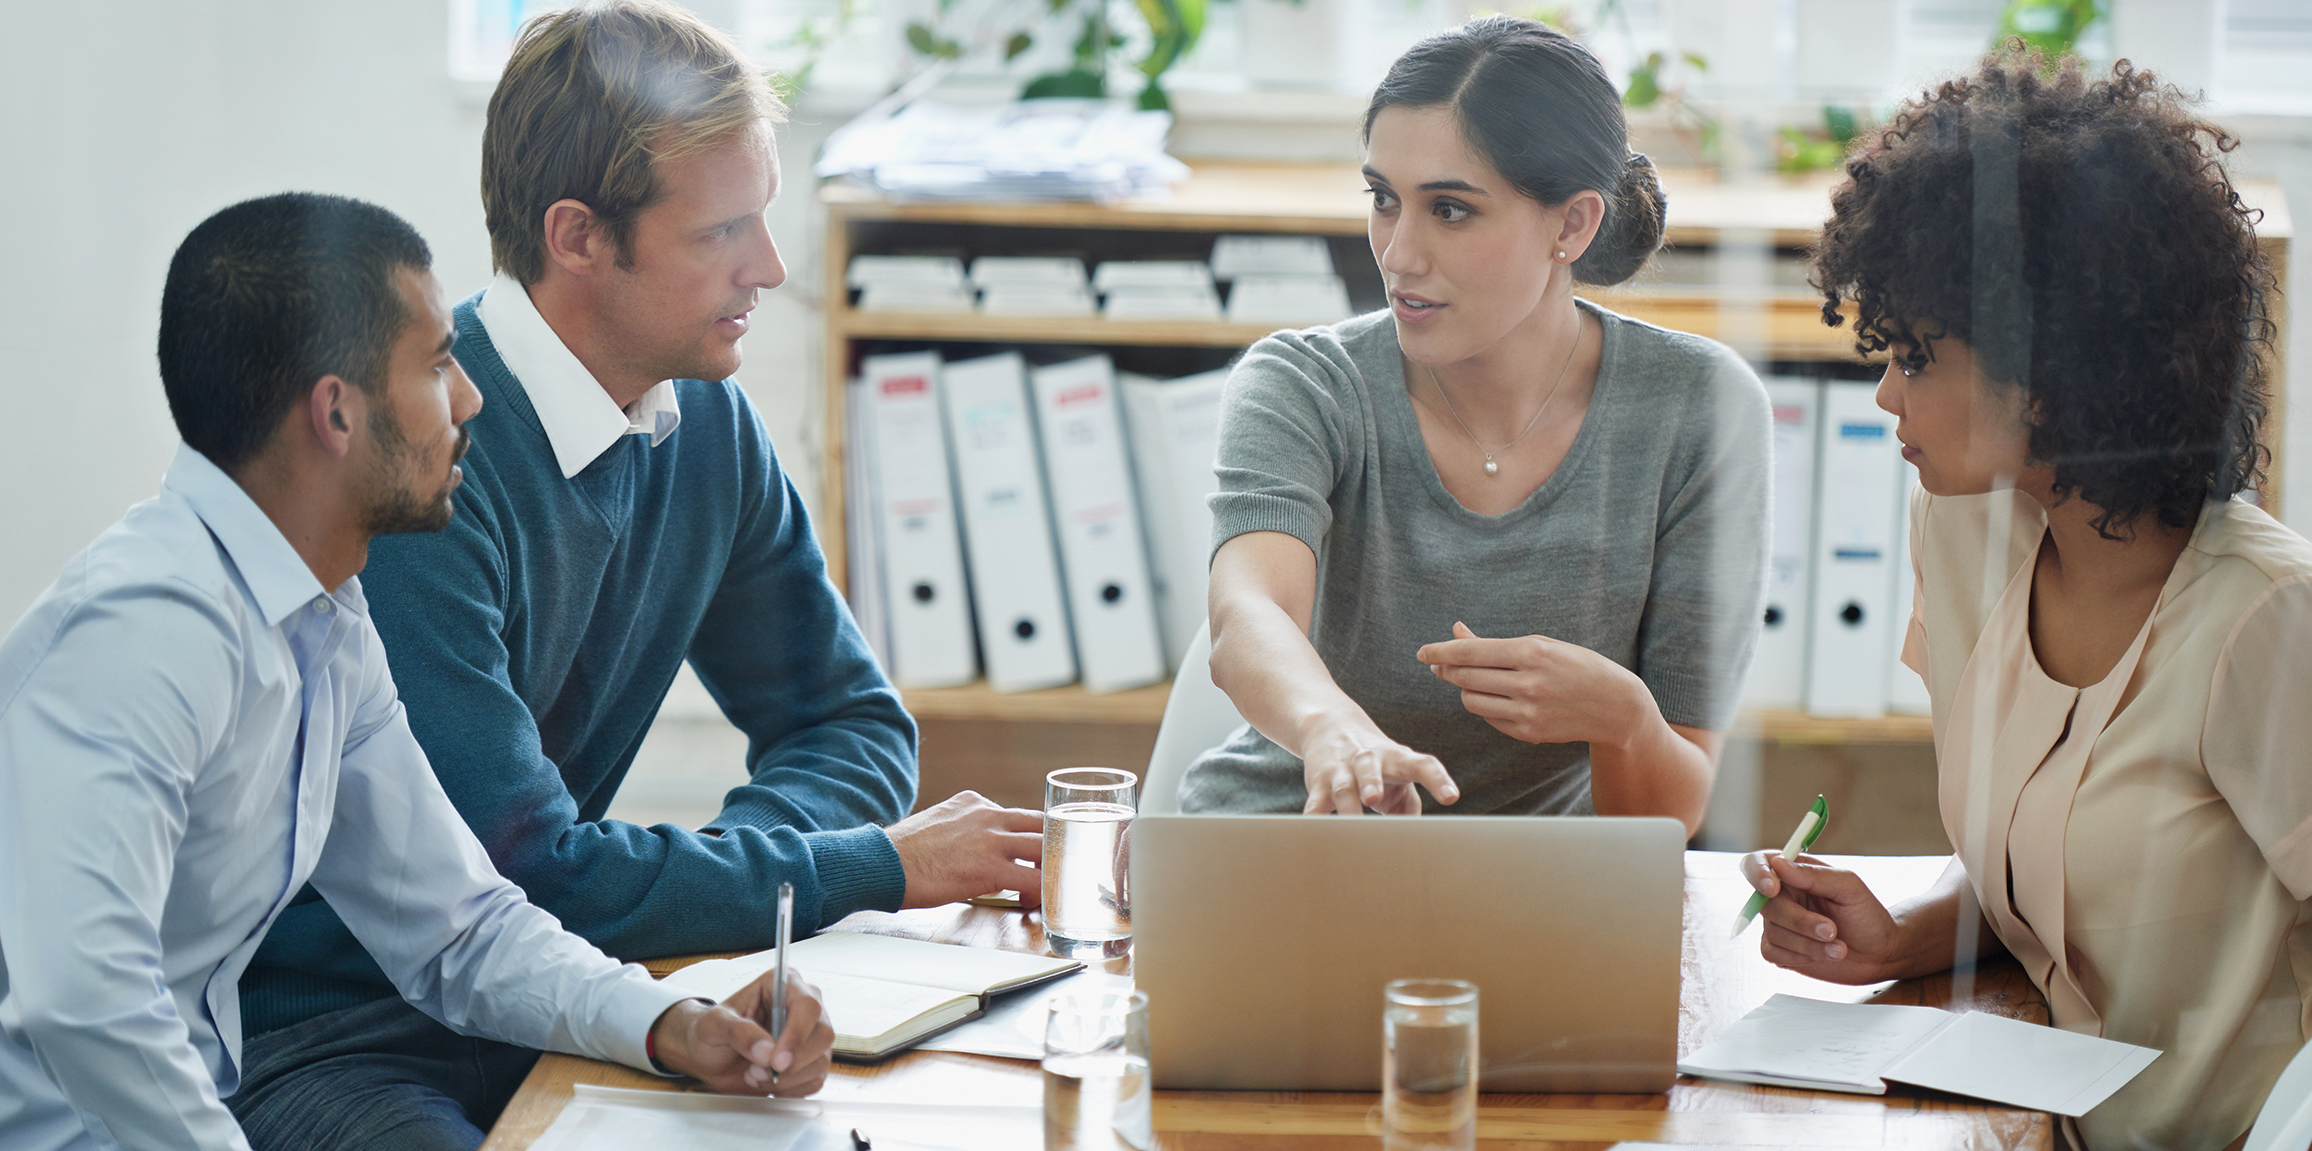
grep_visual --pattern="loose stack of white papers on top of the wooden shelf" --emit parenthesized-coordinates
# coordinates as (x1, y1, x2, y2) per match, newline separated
(814, 99, 1188, 201)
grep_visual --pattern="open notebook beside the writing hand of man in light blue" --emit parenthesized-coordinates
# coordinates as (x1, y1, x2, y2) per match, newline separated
(664, 931, 1084, 1059)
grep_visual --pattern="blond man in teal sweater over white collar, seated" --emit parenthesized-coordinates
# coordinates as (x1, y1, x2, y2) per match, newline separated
(229, 0, 1040, 1151)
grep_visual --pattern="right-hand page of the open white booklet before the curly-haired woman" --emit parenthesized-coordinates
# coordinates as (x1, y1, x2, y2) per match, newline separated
(1887, 1012, 2159, 1119)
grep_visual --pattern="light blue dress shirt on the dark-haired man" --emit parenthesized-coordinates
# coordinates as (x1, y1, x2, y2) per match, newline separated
(0, 446, 684, 1151)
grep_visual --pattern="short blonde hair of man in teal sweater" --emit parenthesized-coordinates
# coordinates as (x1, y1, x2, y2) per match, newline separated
(481, 0, 786, 284)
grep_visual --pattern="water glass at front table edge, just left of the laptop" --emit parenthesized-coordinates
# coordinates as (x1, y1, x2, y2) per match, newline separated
(1043, 992, 1156, 1151)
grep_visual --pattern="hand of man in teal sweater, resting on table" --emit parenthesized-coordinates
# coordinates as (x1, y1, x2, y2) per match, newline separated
(883, 790, 1043, 908)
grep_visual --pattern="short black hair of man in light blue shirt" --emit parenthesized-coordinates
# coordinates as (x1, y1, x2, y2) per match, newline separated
(160, 192, 432, 469)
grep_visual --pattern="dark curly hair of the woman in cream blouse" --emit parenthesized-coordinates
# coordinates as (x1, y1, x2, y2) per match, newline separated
(1813, 42, 2273, 539)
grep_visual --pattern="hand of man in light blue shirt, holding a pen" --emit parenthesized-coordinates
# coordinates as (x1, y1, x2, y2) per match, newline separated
(650, 971, 835, 1098)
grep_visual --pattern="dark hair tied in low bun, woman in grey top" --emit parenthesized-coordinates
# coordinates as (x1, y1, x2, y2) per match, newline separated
(1364, 16, 1669, 284)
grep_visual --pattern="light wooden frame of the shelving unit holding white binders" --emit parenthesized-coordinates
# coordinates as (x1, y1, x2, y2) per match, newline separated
(818, 162, 2291, 744)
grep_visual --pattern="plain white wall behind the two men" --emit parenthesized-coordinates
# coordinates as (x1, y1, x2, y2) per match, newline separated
(0, 0, 816, 629)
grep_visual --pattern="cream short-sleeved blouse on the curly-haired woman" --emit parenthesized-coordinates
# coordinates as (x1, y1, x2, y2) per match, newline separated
(1903, 492, 2312, 1149)
